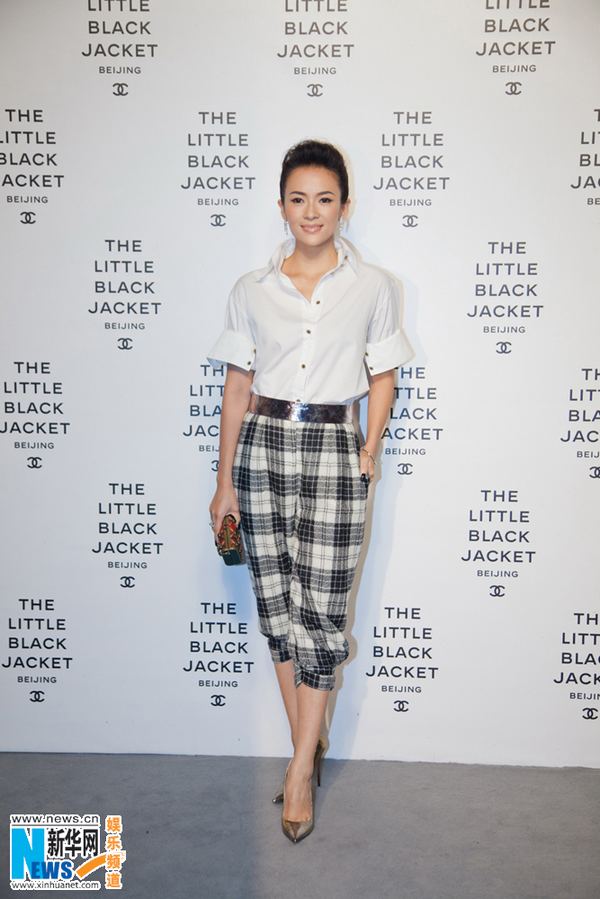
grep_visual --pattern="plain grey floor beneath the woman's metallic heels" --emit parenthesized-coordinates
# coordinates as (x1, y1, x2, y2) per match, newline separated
(0, 753, 600, 899)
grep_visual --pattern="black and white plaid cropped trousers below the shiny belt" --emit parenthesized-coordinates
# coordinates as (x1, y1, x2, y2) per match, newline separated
(232, 412, 368, 690)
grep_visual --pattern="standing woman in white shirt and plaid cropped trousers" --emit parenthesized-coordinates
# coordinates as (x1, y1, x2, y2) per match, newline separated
(207, 140, 413, 842)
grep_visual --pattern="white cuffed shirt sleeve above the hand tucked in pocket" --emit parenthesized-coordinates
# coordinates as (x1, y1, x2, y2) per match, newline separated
(365, 278, 414, 375)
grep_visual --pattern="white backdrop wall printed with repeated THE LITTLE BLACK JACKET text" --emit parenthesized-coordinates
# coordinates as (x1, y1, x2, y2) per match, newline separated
(0, 0, 600, 767)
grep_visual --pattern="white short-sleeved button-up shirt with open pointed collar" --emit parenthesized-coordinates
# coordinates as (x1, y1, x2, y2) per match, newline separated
(207, 238, 414, 403)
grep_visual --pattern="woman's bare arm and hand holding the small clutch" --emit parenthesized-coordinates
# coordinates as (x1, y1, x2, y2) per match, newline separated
(208, 363, 254, 533)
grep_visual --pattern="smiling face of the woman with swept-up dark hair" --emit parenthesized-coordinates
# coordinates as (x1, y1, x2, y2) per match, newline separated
(279, 165, 350, 249)
